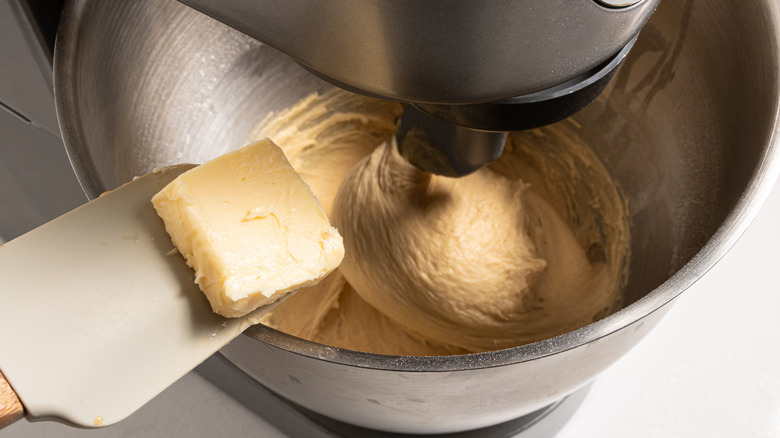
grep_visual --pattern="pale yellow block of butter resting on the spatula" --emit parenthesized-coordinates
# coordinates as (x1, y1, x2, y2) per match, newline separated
(152, 139, 344, 317)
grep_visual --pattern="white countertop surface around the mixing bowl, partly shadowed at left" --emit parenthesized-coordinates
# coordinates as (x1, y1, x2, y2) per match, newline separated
(6, 179, 780, 438)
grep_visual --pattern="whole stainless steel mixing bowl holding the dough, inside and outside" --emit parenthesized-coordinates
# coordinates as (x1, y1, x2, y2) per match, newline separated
(55, 0, 780, 432)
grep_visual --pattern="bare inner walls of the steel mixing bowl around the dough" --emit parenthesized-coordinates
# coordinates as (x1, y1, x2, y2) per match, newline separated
(55, 0, 778, 362)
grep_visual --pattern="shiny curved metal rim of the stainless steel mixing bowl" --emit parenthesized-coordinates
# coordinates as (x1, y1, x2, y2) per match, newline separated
(53, 1, 780, 372)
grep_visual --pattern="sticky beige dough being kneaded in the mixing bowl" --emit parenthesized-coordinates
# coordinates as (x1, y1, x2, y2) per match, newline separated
(255, 90, 629, 355)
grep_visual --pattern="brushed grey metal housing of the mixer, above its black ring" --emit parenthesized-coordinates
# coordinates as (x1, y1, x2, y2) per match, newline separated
(175, 0, 660, 104)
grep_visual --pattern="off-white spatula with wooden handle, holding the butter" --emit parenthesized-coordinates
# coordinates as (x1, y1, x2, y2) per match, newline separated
(0, 165, 273, 428)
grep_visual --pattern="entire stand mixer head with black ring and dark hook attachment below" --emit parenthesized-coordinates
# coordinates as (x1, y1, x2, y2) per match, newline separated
(175, 0, 660, 177)
